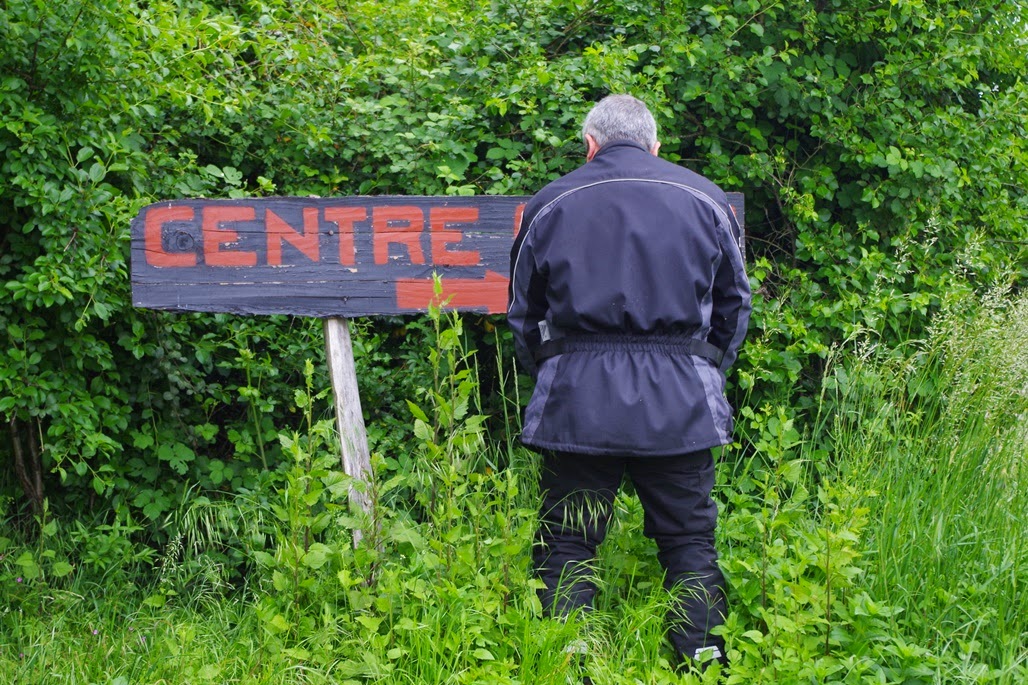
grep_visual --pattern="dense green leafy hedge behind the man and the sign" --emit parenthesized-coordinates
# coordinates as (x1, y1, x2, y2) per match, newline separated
(0, 0, 1028, 680)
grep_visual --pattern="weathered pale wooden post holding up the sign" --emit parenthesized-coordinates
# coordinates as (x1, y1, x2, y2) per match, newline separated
(325, 317, 372, 546)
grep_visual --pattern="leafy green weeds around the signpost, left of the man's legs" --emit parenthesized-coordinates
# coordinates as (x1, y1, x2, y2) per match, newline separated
(237, 308, 540, 678)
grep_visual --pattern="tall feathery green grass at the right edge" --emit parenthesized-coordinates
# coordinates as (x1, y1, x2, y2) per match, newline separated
(827, 287, 1028, 683)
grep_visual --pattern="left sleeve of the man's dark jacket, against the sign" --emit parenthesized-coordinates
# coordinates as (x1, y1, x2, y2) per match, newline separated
(507, 212, 547, 378)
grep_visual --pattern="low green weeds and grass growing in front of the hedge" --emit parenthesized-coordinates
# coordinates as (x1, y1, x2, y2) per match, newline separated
(0, 290, 1028, 684)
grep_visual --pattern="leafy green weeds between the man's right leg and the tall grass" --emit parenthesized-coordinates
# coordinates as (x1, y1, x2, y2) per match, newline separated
(719, 434, 939, 683)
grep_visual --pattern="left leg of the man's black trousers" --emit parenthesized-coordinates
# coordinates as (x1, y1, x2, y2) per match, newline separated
(533, 453, 625, 615)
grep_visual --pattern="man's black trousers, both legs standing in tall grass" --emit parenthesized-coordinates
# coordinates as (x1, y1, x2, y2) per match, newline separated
(534, 449, 726, 658)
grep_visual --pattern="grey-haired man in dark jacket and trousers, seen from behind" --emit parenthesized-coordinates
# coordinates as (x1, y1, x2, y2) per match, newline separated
(507, 95, 750, 662)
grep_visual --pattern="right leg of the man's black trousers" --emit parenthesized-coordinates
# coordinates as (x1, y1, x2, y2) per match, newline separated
(628, 449, 727, 658)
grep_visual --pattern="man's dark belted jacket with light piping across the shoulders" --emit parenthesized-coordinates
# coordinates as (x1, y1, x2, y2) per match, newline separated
(507, 141, 750, 456)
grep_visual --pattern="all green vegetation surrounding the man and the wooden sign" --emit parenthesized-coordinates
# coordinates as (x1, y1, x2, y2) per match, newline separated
(0, 0, 1028, 683)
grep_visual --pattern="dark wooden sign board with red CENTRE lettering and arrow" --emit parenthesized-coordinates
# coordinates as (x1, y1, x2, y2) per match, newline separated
(132, 193, 742, 318)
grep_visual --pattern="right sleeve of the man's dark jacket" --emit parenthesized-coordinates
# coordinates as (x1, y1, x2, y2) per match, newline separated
(707, 207, 751, 372)
